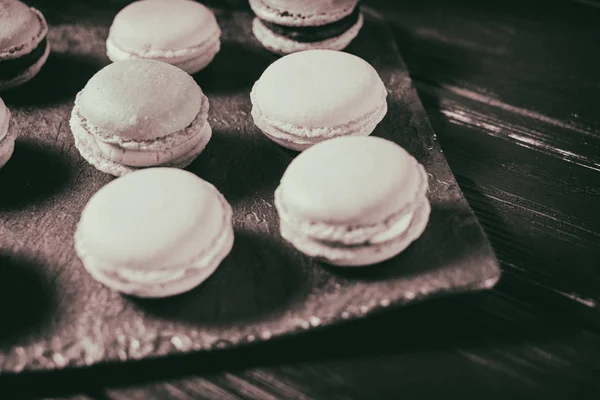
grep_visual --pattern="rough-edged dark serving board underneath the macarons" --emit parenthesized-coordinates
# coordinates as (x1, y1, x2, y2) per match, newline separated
(0, 1, 500, 373)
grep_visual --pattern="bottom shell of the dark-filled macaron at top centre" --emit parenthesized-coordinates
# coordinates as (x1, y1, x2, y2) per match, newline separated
(252, 14, 364, 55)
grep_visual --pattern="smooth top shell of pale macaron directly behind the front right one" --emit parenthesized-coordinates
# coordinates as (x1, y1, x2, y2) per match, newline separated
(252, 49, 387, 128)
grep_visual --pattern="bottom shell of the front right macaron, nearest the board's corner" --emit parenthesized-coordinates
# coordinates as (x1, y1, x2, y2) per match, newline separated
(280, 199, 431, 267)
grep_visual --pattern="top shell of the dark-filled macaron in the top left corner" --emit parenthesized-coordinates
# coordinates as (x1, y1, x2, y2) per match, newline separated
(0, 0, 47, 57)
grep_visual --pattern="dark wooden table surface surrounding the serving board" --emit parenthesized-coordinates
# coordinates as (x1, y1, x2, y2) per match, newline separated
(0, 0, 600, 400)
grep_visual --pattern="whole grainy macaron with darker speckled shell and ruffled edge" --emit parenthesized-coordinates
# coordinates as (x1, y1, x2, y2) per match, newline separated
(70, 59, 212, 176)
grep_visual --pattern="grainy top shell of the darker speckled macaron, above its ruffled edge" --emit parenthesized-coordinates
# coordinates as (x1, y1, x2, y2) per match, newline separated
(76, 59, 205, 141)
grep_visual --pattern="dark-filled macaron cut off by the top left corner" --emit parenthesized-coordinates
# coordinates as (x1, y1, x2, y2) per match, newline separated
(0, 0, 50, 91)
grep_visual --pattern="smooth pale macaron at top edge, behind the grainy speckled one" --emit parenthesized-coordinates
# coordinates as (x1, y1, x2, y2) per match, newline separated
(106, 0, 221, 74)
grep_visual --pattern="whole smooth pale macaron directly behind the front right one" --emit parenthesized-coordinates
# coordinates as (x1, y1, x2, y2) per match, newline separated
(250, 49, 387, 151)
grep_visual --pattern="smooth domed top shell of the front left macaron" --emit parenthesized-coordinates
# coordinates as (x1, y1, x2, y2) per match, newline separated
(76, 168, 224, 270)
